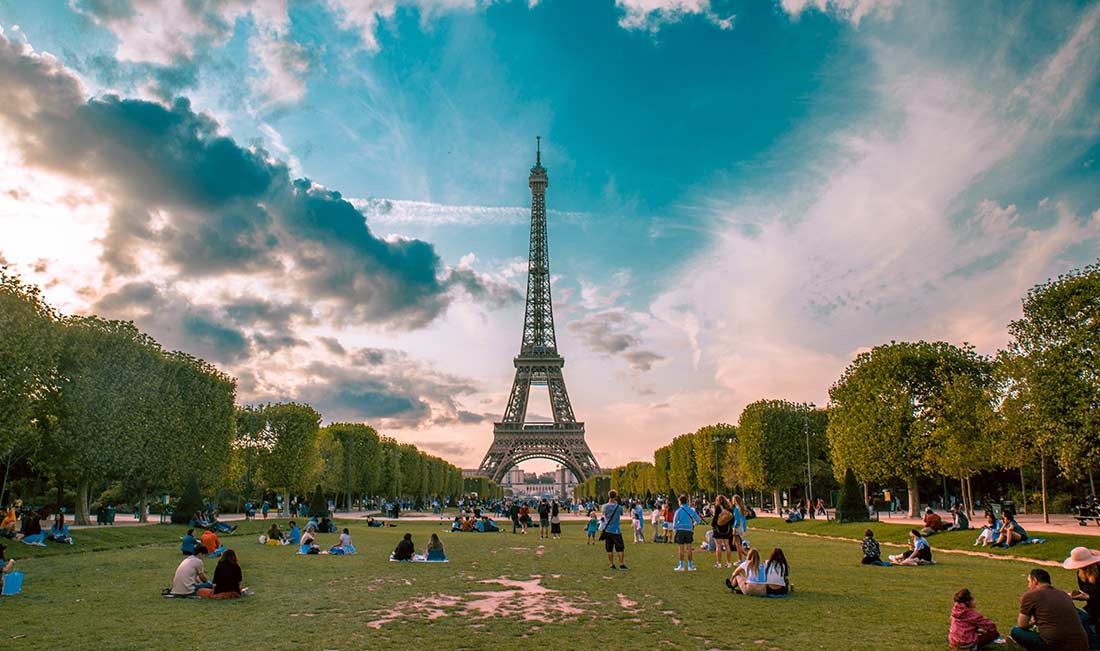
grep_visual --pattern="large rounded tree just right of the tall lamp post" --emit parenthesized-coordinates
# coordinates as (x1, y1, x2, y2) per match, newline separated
(827, 341, 982, 518)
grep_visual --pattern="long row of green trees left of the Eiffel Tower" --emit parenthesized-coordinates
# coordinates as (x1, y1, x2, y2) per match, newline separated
(0, 267, 463, 523)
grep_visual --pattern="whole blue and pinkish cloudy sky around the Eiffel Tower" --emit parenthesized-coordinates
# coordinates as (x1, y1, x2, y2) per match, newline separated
(0, 0, 1100, 465)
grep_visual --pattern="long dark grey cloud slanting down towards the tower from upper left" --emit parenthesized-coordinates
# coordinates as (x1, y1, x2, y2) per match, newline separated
(0, 31, 518, 328)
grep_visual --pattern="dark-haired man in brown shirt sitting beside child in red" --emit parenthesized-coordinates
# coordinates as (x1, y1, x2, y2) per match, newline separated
(1011, 569, 1089, 651)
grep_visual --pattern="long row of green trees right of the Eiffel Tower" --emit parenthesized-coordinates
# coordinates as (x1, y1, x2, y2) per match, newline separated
(576, 257, 1100, 517)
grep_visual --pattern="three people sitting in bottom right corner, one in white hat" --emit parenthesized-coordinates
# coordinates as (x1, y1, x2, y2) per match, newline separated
(947, 547, 1100, 651)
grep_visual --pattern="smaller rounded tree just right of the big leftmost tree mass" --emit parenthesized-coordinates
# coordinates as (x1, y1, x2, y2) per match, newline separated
(261, 402, 321, 509)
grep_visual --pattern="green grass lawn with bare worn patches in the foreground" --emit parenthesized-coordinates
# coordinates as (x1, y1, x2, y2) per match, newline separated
(0, 519, 1073, 651)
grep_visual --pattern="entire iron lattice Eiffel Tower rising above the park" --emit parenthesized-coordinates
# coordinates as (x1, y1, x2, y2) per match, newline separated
(480, 139, 600, 484)
